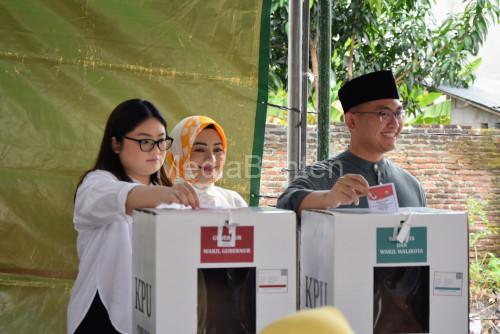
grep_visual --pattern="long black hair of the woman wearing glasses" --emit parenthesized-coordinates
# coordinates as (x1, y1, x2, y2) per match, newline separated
(77, 99, 172, 194)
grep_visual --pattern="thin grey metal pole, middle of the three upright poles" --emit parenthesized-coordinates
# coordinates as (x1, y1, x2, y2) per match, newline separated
(300, 0, 309, 170)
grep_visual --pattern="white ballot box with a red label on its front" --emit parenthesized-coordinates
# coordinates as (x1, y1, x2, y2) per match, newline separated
(132, 208, 297, 334)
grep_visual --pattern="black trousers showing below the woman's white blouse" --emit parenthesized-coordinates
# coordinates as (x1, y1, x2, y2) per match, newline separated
(75, 292, 120, 334)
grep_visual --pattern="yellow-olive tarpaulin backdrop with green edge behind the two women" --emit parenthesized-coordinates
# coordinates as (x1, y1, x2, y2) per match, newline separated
(0, 0, 270, 334)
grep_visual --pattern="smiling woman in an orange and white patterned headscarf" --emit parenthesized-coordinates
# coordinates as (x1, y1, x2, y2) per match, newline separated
(167, 116, 248, 208)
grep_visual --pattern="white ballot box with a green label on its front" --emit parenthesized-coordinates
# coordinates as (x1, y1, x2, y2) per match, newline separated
(300, 208, 468, 334)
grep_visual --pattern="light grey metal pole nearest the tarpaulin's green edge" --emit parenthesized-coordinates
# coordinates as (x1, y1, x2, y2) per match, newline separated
(287, 0, 302, 182)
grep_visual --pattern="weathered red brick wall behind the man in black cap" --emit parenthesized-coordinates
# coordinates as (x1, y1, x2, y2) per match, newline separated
(260, 124, 500, 254)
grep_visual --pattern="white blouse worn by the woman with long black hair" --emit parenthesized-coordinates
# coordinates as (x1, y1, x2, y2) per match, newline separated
(68, 170, 140, 333)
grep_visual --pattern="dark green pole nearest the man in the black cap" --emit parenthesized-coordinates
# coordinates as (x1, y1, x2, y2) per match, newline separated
(318, 0, 332, 160)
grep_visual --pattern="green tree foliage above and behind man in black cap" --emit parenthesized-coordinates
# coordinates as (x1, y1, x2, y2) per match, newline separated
(270, 0, 500, 119)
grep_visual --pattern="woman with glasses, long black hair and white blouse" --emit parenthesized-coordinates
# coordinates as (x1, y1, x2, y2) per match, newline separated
(68, 99, 199, 333)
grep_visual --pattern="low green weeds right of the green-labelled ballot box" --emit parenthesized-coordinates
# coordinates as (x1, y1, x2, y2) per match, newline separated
(467, 198, 500, 304)
